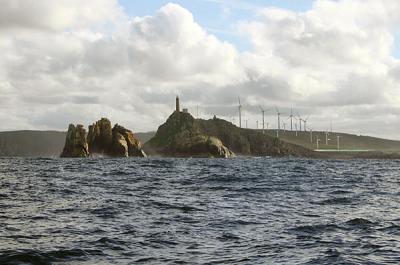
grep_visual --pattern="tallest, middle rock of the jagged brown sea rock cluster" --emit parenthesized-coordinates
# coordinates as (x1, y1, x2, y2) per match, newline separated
(87, 118, 113, 155)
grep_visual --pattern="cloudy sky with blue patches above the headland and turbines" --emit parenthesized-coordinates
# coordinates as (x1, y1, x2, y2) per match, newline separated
(0, 0, 400, 139)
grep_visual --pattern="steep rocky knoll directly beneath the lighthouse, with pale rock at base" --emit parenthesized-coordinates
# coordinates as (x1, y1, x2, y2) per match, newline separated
(144, 111, 234, 158)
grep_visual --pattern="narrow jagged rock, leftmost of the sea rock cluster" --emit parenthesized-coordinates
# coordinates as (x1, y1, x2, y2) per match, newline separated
(61, 124, 89, 157)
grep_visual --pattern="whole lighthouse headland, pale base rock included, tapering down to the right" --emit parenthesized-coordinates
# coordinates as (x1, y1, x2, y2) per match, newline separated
(144, 112, 317, 157)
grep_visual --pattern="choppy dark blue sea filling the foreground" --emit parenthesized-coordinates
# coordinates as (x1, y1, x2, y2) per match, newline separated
(0, 158, 400, 264)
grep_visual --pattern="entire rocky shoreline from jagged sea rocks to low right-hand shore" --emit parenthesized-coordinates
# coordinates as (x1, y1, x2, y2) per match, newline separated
(61, 111, 400, 159)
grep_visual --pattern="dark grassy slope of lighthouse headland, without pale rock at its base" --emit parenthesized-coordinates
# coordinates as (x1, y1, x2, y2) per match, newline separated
(144, 112, 317, 157)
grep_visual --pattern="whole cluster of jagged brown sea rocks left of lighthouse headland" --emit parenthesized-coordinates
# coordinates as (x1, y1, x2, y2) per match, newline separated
(62, 118, 146, 157)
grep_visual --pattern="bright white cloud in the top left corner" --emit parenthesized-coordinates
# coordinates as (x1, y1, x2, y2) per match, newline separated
(0, 0, 123, 30)
